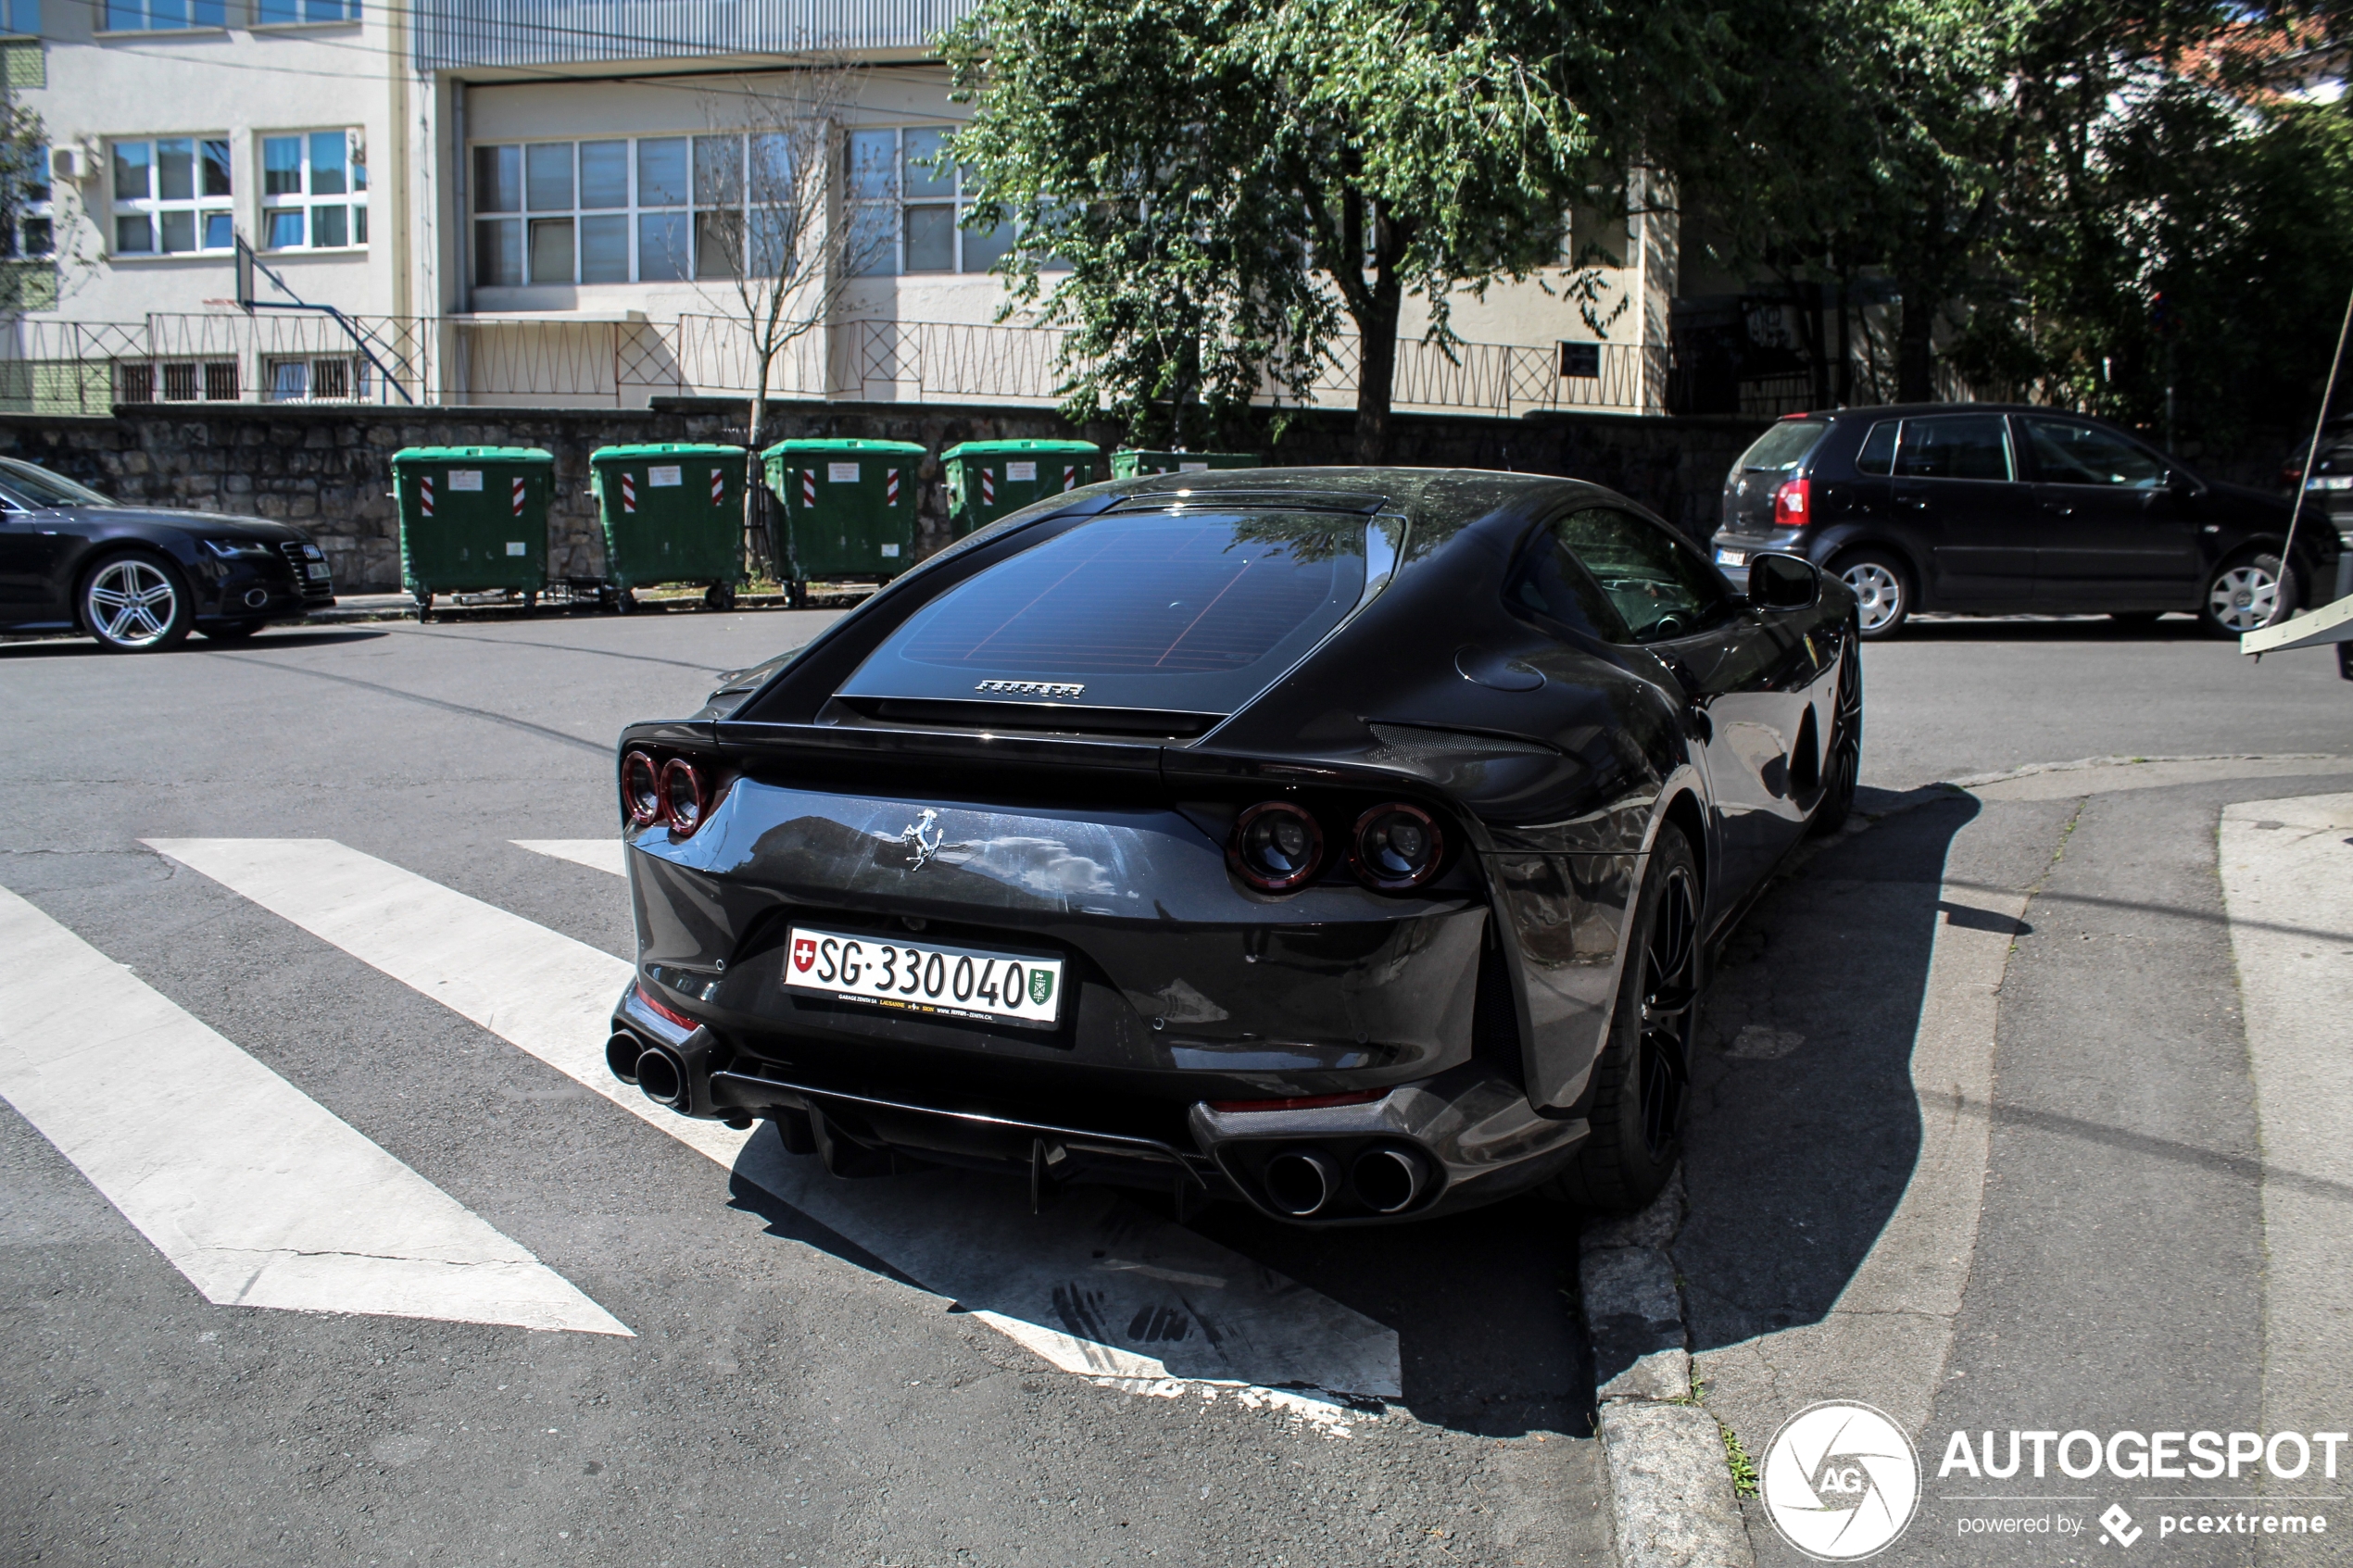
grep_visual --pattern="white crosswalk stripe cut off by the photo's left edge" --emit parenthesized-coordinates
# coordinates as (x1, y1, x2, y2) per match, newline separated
(0, 888, 628, 1336)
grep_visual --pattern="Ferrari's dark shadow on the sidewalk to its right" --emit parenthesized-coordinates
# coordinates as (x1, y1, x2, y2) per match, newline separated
(1675, 790, 1985, 1354)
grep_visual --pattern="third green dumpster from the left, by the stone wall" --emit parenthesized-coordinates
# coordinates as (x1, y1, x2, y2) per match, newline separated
(760, 440, 925, 604)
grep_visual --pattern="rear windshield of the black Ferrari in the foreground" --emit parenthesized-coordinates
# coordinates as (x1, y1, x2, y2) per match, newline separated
(842, 510, 1367, 712)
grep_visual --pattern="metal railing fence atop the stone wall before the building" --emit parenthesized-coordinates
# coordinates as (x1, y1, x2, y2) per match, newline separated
(0, 310, 1666, 416)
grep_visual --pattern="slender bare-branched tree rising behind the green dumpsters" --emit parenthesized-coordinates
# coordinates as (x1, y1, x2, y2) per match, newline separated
(691, 61, 894, 575)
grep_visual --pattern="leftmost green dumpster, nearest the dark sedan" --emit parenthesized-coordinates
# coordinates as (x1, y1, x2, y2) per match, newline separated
(393, 446, 555, 621)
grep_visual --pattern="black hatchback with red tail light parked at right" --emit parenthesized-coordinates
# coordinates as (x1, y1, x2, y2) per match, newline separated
(1713, 405, 2339, 637)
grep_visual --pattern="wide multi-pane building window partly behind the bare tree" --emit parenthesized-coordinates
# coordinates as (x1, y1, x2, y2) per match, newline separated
(473, 132, 790, 289)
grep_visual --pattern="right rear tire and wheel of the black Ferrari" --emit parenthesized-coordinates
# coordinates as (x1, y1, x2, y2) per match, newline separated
(1548, 825, 1701, 1213)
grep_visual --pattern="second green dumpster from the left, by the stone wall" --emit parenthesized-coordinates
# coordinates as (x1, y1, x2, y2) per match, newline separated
(588, 442, 744, 613)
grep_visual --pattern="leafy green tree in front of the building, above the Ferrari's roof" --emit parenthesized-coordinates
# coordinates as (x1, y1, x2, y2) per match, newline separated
(946, 0, 1635, 463)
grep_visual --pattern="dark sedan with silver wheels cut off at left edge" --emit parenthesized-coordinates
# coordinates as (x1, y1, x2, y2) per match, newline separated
(0, 458, 334, 654)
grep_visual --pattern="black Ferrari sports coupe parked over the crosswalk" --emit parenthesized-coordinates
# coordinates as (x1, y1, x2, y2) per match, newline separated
(610, 468, 1864, 1224)
